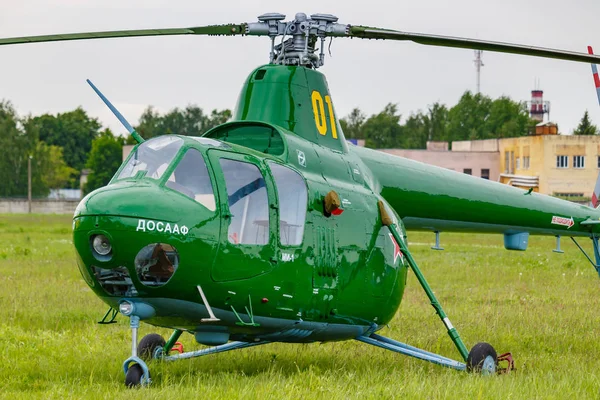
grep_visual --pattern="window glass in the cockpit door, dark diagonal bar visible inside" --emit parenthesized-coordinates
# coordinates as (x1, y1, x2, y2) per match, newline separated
(219, 158, 269, 244)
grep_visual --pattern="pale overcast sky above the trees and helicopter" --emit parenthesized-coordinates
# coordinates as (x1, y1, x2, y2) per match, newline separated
(0, 0, 600, 133)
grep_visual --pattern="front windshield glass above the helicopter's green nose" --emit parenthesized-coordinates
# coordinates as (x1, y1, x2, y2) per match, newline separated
(117, 136, 183, 179)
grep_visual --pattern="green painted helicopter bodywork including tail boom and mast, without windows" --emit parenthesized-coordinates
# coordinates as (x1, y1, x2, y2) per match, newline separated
(73, 65, 600, 341)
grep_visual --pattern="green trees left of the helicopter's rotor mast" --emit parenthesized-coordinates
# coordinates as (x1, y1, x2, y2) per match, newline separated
(0, 101, 231, 197)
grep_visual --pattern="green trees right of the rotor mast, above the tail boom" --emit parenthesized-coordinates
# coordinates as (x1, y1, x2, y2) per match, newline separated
(340, 91, 598, 149)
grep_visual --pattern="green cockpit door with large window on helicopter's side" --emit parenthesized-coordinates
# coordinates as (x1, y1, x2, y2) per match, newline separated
(208, 150, 277, 282)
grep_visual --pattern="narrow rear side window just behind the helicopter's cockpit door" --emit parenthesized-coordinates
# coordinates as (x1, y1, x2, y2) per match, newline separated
(269, 162, 308, 246)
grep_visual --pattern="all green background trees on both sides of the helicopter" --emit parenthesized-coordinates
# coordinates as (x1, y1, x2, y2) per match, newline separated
(0, 91, 598, 197)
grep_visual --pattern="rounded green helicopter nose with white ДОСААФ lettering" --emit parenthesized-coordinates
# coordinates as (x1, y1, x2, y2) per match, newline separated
(73, 182, 220, 298)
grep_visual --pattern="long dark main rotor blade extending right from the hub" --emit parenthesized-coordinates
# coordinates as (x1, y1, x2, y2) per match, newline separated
(348, 26, 600, 64)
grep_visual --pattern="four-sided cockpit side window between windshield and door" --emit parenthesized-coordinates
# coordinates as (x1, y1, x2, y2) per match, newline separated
(166, 149, 216, 211)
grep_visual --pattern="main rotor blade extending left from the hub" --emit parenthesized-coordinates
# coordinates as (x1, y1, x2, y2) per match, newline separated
(0, 24, 246, 46)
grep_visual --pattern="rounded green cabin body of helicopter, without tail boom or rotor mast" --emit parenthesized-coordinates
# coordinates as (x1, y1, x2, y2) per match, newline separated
(74, 129, 407, 343)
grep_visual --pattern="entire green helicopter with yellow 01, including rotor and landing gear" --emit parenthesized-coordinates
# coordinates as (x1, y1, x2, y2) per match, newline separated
(0, 9, 600, 385)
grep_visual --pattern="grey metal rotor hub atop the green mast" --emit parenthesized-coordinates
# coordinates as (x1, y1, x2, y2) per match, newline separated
(246, 13, 349, 69)
